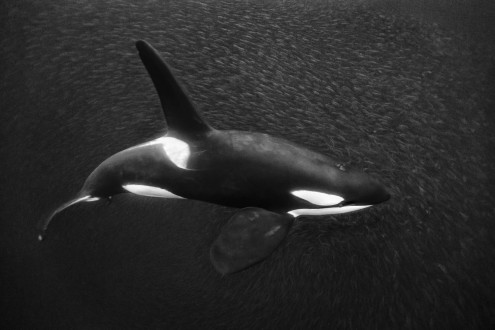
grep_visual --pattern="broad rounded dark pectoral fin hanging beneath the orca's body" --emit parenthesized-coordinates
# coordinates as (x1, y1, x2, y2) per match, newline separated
(210, 207, 293, 274)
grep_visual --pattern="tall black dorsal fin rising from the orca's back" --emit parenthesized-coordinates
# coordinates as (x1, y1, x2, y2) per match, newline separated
(136, 40, 211, 138)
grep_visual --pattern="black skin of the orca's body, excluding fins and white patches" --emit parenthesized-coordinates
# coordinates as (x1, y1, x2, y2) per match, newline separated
(80, 130, 390, 212)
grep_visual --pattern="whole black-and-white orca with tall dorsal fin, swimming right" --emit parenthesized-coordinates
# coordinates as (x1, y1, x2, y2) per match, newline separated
(39, 40, 390, 274)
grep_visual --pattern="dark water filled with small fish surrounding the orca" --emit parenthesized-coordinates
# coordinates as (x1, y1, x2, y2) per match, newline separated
(0, 1, 495, 329)
